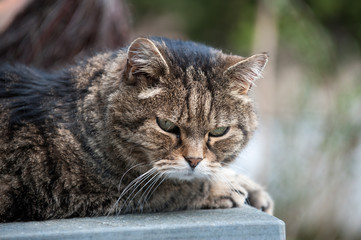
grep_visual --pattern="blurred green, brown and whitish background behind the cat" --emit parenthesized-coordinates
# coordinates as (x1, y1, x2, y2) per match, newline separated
(0, 0, 361, 240)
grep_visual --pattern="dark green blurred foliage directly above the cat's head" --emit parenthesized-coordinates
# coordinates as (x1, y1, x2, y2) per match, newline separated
(129, 0, 256, 53)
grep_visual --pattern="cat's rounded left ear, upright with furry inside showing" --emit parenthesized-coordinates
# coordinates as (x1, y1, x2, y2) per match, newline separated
(125, 38, 169, 83)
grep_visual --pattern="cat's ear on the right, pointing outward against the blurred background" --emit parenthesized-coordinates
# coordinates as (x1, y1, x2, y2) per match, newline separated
(223, 53, 268, 94)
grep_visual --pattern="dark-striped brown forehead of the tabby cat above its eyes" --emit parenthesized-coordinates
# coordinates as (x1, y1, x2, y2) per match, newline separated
(157, 74, 243, 130)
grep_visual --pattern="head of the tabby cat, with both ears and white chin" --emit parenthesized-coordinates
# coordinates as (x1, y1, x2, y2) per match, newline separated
(105, 38, 268, 180)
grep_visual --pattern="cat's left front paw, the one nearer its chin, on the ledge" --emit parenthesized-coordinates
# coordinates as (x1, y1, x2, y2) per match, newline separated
(203, 178, 248, 208)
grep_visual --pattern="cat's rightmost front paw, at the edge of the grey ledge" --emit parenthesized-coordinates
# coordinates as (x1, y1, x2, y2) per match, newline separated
(246, 189, 274, 215)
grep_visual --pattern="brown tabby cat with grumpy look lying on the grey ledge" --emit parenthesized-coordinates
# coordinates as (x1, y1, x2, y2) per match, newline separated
(0, 38, 273, 222)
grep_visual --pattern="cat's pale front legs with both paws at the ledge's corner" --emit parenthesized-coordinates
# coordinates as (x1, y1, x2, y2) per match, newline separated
(204, 169, 273, 214)
